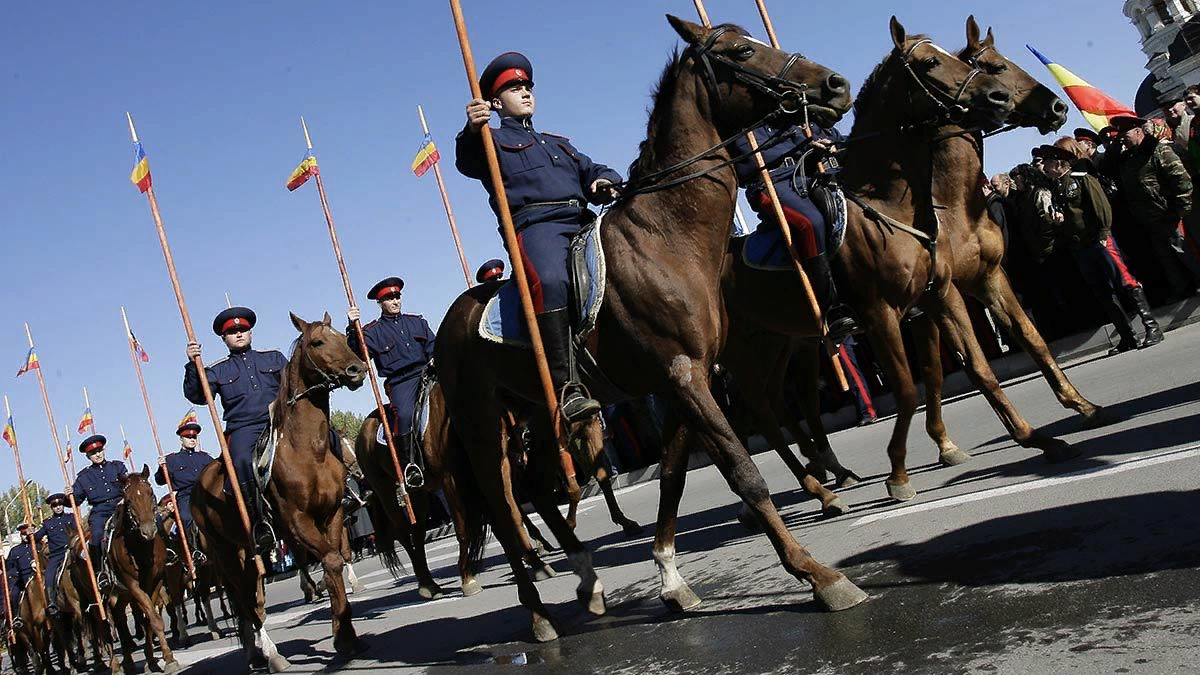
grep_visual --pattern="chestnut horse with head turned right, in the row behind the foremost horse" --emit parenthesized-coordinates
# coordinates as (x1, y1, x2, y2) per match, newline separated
(192, 313, 366, 673)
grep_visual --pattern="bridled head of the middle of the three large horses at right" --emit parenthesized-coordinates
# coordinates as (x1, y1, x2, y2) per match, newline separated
(854, 17, 1013, 129)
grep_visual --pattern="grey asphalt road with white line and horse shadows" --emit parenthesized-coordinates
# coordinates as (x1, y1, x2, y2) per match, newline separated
(169, 325, 1200, 675)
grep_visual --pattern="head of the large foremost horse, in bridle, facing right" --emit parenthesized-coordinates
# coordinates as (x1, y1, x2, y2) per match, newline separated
(667, 14, 851, 131)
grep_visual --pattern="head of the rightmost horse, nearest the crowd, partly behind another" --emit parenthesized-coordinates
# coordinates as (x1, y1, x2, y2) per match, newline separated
(959, 16, 1067, 133)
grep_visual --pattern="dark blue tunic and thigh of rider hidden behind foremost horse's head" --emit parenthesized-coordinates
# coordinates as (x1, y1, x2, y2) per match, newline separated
(733, 119, 842, 259)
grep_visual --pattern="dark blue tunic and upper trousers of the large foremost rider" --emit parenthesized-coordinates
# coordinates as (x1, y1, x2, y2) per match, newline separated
(455, 118, 620, 313)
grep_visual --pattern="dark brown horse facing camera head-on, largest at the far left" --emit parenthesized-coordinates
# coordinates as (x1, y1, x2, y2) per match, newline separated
(106, 465, 179, 674)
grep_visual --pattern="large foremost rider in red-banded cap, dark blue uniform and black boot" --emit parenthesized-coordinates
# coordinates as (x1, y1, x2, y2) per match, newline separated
(455, 52, 620, 422)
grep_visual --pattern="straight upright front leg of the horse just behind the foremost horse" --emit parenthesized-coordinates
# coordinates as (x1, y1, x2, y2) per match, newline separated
(863, 301, 917, 502)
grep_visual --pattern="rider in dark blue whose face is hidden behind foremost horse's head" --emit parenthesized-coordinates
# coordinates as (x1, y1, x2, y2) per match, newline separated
(733, 124, 858, 339)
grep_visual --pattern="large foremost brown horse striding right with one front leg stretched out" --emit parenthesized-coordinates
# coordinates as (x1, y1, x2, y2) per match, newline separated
(436, 17, 866, 640)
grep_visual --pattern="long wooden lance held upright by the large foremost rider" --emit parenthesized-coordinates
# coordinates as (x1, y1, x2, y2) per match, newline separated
(450, 0, 575, 484)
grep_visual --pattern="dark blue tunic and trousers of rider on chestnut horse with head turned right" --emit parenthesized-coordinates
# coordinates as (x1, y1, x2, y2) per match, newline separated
(182, 350, 288, 483)
